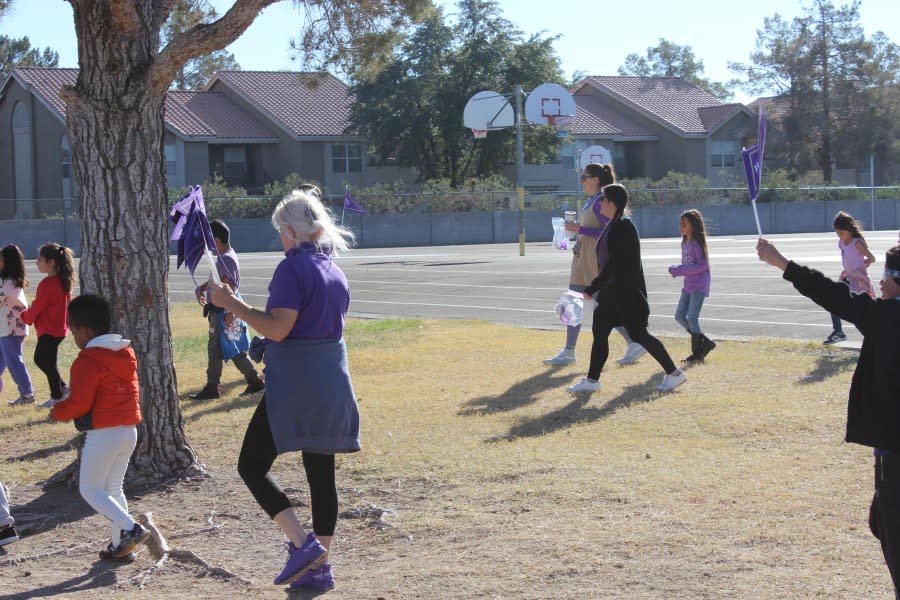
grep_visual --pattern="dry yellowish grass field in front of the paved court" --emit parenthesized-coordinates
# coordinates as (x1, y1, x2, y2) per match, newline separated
(0, 306, 893, 600)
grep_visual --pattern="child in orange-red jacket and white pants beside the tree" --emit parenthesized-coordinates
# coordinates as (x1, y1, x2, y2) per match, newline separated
(50, 294, 150, 560)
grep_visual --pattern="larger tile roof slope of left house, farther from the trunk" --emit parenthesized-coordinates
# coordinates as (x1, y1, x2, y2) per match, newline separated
(207, 71, 350, 137)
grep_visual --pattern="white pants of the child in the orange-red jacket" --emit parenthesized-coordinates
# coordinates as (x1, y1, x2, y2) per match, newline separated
(78, 425, 137, 546)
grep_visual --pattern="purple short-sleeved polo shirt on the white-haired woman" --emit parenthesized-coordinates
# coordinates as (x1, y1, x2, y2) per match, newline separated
(266, 242, 350, 339)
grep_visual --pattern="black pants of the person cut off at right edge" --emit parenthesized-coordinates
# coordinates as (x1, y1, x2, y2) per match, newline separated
(869, 453, 900, 597)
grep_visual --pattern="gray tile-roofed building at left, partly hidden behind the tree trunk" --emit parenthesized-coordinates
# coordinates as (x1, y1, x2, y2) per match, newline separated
(0, 67, 414, 218)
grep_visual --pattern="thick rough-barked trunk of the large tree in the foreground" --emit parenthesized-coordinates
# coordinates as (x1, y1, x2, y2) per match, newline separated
(63, 0, 203, 485)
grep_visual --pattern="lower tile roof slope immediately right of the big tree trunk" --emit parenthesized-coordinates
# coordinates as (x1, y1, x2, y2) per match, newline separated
(166, 91, 278, 141)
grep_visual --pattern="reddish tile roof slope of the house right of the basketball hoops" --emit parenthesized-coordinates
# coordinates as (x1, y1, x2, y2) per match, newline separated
(583, 76, 722, 134)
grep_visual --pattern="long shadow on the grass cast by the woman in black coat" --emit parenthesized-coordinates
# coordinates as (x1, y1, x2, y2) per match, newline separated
(486, 375, 664, 442)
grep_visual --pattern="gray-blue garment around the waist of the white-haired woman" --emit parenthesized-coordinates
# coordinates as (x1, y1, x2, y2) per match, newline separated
(265, 338, 361, 454)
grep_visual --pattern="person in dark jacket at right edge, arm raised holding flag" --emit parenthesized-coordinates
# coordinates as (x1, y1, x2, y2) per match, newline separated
(756, 239, 900, 597)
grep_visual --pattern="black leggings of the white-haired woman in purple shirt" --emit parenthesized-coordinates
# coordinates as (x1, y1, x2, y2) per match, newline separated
(238, 396, 338, 536)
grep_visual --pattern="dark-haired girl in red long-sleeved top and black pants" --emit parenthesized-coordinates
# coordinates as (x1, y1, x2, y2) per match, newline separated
(21, 242, 75, 408)
